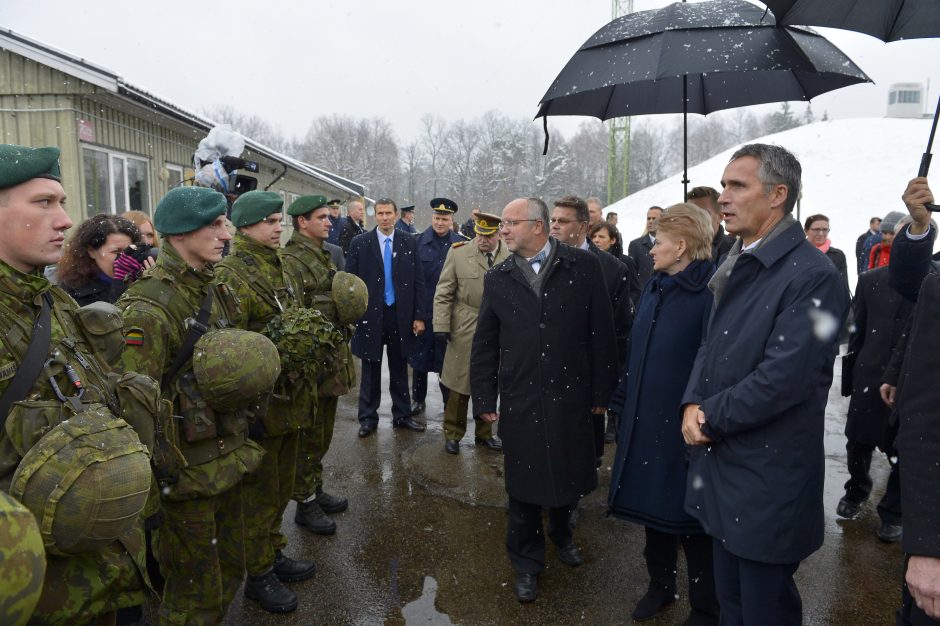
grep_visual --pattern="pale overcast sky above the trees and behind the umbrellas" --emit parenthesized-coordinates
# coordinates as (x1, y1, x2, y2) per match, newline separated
(0, 0, 940, 141)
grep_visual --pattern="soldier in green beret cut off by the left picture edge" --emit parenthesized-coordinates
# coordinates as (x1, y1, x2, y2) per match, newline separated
(0, 144, 152, 624)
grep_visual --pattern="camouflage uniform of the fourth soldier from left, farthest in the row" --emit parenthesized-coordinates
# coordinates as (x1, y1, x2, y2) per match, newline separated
(281, 231, 356, 502)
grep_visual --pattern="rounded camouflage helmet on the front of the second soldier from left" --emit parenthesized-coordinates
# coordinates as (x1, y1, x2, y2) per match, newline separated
(193, 328, 281, 411)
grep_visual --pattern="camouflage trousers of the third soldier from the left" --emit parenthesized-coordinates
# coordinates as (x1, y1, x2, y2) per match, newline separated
(242, 430, 298, 576)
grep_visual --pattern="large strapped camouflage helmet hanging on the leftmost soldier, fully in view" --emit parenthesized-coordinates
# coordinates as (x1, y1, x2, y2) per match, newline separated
(10, 404, 151, 555)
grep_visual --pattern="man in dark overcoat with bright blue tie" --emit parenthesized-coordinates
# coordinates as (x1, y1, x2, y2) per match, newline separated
(346, 199, 430, 437)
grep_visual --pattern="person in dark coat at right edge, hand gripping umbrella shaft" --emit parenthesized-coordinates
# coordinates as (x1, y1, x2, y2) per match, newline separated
(889, 177, 940, 624)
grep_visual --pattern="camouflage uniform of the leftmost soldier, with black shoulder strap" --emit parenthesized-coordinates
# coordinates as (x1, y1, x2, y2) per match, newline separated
(0, 261, 152, 624)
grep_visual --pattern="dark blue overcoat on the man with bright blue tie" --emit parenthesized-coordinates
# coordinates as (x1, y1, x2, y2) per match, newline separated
(346, 229, 430, 361)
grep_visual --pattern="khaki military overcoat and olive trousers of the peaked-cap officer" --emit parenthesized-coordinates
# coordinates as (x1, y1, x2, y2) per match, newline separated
(434, 232, 509, 441)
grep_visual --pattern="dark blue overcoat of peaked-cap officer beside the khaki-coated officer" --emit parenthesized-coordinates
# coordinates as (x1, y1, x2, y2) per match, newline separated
(408, 228, 466, 372)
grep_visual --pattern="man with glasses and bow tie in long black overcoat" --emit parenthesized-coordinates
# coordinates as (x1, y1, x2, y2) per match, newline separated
(470, 198, 618, 602)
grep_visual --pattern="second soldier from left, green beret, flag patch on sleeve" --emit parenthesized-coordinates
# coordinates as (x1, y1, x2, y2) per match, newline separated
(117, 187, 266, 625)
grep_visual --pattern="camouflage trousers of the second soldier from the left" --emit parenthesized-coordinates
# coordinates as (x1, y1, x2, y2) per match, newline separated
(154, 484, 245, 626)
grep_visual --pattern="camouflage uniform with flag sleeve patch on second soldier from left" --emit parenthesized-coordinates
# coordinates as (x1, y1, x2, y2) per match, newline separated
(117, 241, 264, 624)
